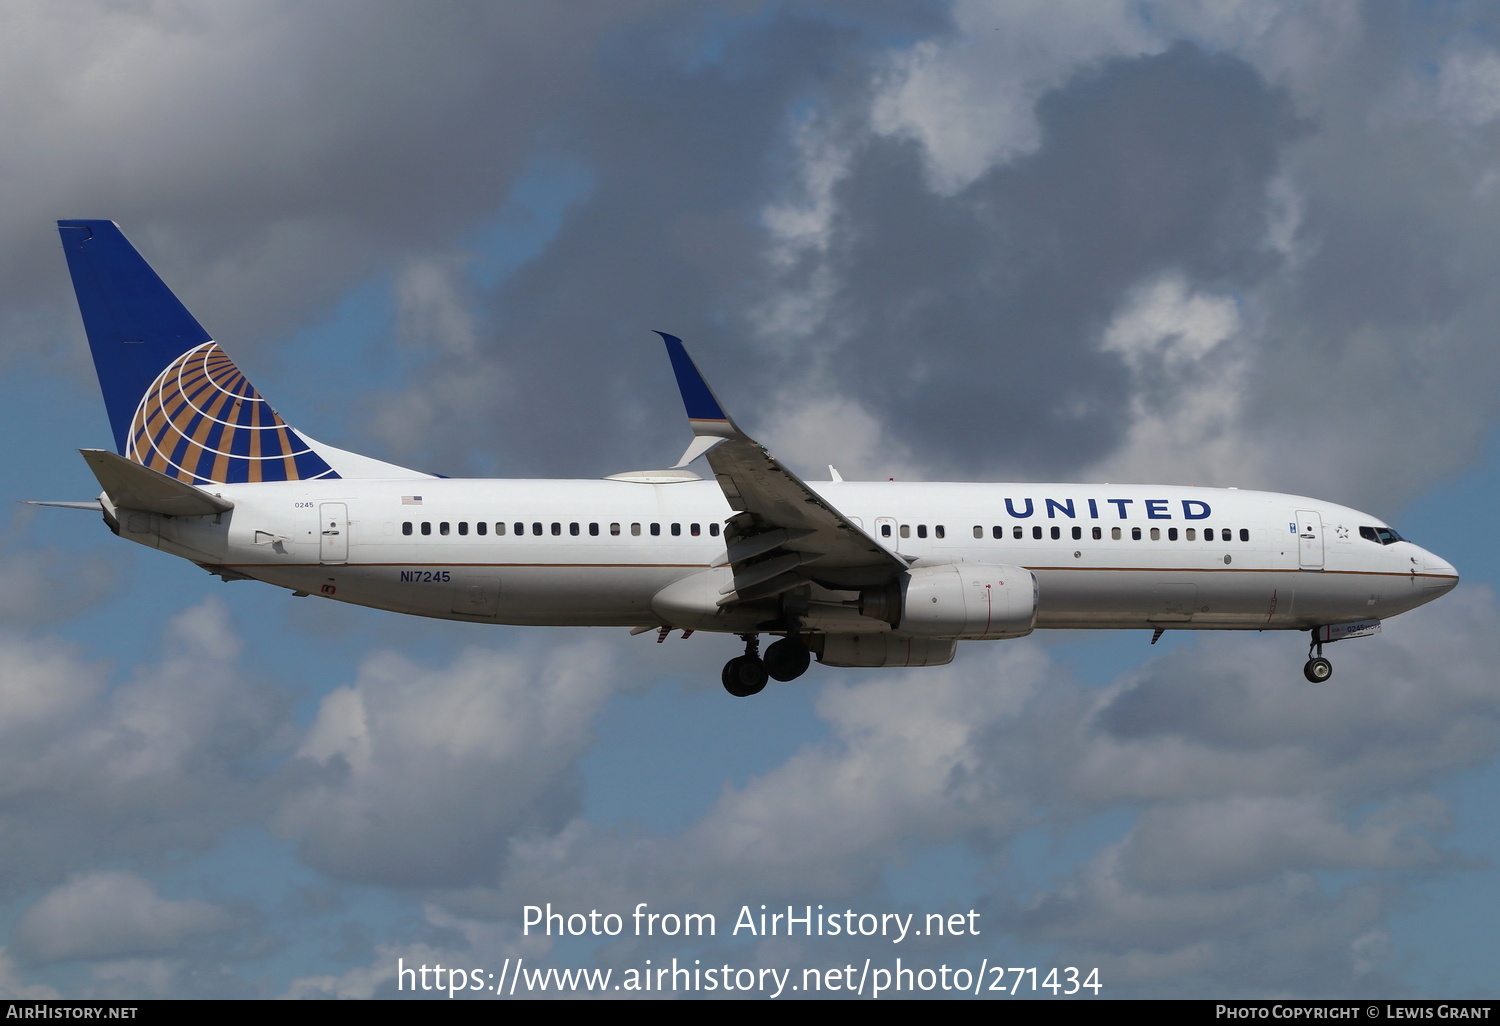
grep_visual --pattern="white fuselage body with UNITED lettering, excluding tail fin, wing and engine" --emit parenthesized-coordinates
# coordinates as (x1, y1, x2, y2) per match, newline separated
(119, 479, 1458, 632)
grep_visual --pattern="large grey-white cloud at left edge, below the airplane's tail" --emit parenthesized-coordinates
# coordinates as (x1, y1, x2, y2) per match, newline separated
(0, 602, 287, 894)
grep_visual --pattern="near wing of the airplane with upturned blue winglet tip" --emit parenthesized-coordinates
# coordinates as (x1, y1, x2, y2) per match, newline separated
(657, 332, 909, 605)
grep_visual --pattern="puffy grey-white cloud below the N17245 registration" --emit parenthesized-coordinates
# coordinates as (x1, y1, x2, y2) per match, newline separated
(278, 645, 611, 887)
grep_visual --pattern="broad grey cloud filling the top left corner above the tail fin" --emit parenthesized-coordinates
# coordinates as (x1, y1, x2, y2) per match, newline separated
(0, 0, 674, 363)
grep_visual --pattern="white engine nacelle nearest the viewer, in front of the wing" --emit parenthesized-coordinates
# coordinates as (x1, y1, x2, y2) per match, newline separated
(861, 563, 1037, 639)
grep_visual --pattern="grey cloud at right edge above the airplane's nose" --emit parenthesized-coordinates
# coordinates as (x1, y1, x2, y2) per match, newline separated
(1244, 71, 1500, 515)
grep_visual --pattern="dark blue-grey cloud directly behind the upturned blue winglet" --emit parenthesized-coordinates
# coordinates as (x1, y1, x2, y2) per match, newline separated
(381, 6, 948, 474)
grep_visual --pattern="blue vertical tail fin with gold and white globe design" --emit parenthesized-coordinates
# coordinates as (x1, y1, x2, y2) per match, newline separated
(57, 221, 339, 485)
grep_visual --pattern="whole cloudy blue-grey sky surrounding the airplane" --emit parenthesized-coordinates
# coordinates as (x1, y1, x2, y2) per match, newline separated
(0, 0, 1500, 998)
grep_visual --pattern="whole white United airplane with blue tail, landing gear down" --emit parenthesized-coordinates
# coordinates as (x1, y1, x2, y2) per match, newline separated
(44, 221, 1458, 698)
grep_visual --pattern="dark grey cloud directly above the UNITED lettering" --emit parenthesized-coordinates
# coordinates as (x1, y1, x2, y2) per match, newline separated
(786, 45, 1301, 474)
